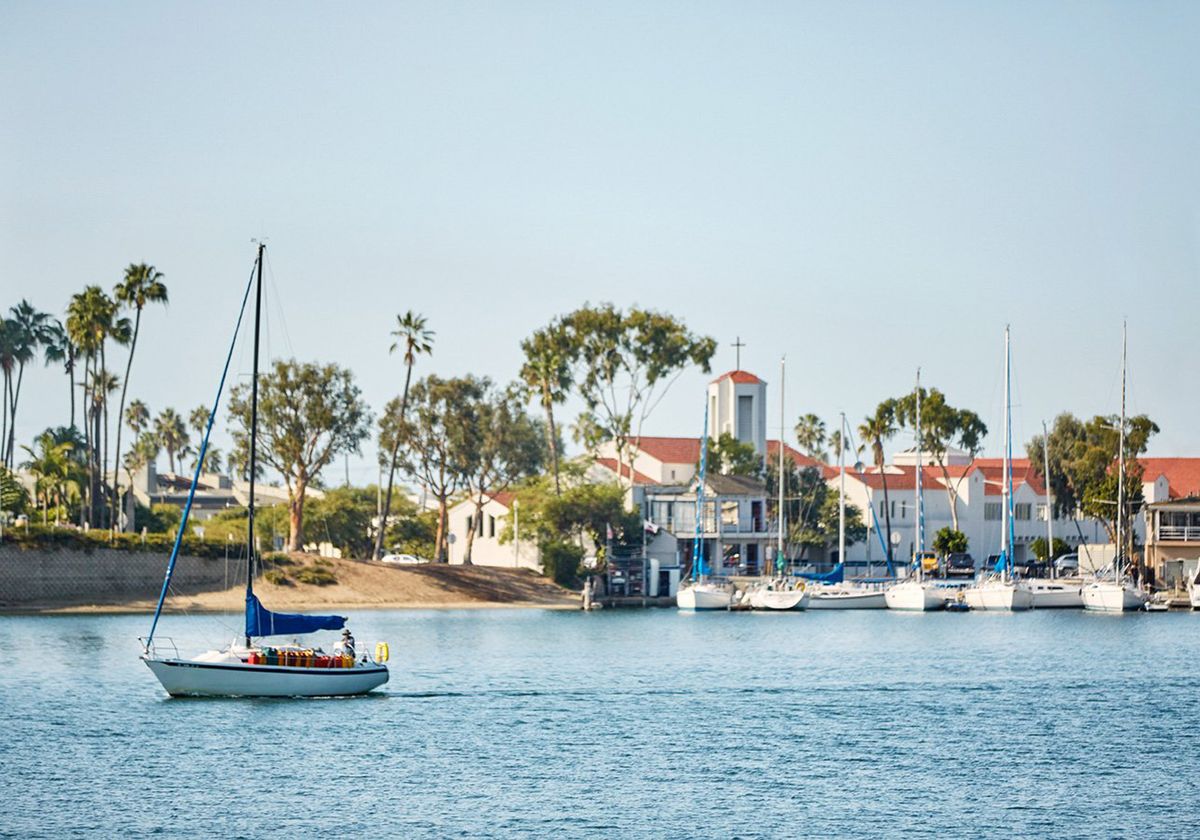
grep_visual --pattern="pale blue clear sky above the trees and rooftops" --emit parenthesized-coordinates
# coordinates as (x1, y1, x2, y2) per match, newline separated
(0, 0, 1200, 484)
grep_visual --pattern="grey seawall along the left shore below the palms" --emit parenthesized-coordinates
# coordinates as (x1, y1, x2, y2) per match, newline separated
(0, 546, 236, 610)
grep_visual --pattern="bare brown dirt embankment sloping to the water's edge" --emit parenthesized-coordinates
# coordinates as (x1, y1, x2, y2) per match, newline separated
(21, 554, 580, 612)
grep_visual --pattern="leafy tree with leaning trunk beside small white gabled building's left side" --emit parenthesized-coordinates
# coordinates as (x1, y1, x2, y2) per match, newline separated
(462, 379, 545, 565)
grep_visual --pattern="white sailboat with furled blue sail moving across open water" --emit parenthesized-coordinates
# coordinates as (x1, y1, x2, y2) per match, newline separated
(139, 244, 389, 697)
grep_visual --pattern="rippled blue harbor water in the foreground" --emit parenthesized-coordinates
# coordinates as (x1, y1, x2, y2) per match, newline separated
(0, 610, 1200, 838)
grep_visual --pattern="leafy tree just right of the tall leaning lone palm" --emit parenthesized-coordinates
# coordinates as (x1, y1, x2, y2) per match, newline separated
(391, 376, 485, 563)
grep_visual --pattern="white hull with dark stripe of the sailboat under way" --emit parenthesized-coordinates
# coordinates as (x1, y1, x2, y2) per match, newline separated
(142, 656, 388, 697)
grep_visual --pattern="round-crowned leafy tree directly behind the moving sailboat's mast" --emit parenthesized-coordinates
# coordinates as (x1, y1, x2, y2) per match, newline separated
(229, 359, 371, 551)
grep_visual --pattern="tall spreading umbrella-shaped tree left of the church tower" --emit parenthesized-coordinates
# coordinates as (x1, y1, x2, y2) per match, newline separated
(562, 304, 716, 492)
